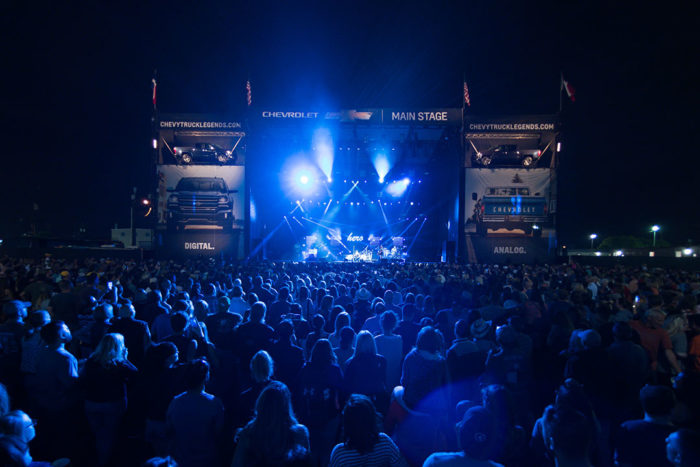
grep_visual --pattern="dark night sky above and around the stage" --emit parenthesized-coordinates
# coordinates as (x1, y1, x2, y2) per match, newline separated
(0, 1, 700, 247)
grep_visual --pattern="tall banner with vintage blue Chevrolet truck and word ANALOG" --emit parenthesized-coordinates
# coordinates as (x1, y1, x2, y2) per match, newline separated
(464, 168, 556, 263)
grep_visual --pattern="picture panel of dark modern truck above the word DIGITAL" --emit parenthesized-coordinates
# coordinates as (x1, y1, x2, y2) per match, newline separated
(158, 165, 246, 232)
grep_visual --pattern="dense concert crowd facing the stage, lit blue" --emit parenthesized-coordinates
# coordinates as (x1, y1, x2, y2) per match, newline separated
(0, 257, 700, 467)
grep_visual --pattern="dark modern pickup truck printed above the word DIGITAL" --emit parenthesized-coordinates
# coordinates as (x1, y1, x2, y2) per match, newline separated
(167, 177, 237, 230)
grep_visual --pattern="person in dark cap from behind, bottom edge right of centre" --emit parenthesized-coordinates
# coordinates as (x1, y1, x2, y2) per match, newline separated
(423, 406, 502, 467)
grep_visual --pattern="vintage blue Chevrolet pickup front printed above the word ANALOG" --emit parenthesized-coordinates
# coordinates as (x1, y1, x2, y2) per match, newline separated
(472, 186, 548, 235)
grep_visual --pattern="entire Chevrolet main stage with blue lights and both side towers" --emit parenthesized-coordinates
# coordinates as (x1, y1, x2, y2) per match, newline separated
(154, 108, 560, 263)
